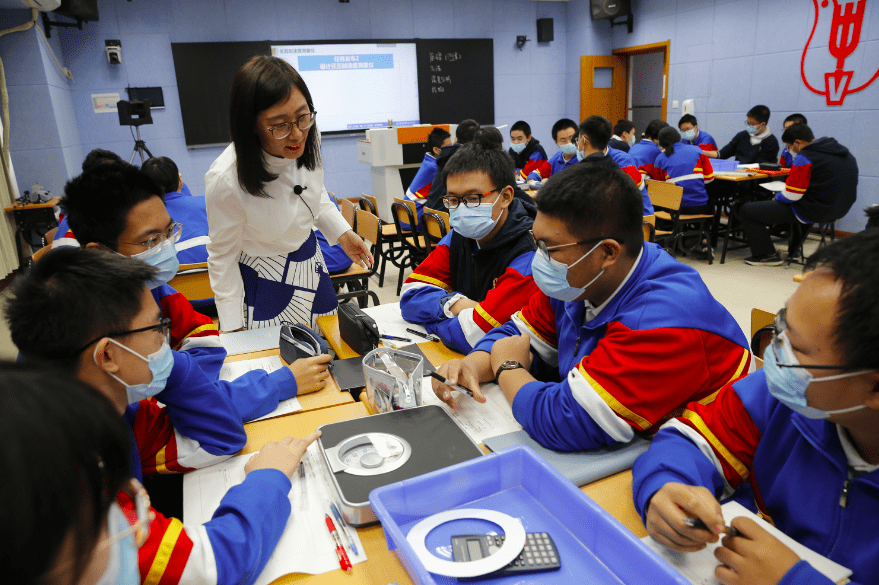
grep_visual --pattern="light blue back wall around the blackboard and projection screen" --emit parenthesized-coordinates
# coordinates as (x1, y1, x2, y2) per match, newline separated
(0, 0, 584, 202)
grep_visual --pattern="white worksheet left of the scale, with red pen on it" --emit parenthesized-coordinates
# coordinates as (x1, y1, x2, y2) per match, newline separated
(183, 443, 366, 585)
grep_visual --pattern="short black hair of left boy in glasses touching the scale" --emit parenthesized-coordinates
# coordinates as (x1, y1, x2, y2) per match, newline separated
(4, 247, 158, 371)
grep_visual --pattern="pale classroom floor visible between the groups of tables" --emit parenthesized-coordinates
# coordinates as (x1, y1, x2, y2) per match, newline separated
(0, 236, 818, 359)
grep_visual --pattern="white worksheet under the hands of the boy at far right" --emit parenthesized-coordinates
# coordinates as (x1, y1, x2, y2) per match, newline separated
(641, 502, 852, 585)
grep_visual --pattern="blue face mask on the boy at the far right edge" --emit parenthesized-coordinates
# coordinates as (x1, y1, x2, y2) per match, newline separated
(763, 333, 872, 419)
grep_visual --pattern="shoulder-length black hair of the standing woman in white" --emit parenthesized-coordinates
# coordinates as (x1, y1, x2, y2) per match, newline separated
(229, 55, 321, 198)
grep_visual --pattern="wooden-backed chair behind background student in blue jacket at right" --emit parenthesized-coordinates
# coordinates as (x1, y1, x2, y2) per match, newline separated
(647, 179, 714, 265)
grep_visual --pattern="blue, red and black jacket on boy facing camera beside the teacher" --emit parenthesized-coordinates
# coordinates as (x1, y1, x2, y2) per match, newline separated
(400, 199, 538, 353)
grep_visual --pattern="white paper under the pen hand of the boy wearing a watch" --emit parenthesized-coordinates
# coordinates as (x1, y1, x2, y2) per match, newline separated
(421, 378, 522, 443)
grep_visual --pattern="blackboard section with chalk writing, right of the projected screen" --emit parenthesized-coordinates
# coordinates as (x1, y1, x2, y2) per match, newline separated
(415, 39, 494, 124)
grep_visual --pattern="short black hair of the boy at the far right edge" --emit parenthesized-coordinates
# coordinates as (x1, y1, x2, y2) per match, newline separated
(804, 230, 879, 370)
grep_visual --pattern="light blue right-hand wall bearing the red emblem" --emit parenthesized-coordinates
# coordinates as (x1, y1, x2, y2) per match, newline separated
(620, 0, 879, 231)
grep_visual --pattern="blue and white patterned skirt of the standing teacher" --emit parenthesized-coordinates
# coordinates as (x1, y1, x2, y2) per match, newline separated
(238, 231, 339, 329)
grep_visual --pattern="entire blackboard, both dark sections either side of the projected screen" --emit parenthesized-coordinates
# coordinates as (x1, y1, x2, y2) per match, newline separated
(171, 39, 494, 147)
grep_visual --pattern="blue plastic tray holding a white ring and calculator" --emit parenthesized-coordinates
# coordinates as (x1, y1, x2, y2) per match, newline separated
(369, 446, 689, 585)
